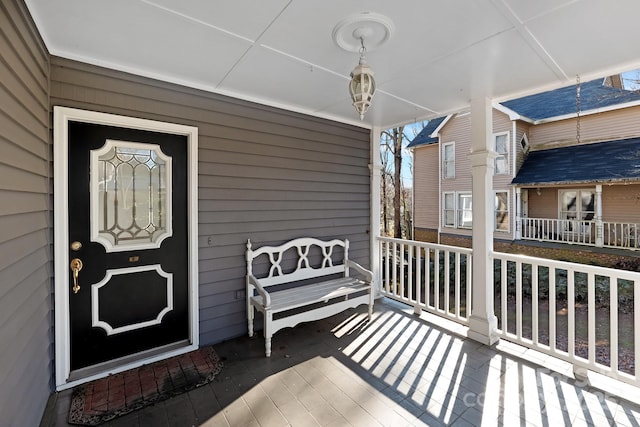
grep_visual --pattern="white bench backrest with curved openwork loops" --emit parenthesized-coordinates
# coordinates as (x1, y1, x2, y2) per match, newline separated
(247, 237, 349, 286)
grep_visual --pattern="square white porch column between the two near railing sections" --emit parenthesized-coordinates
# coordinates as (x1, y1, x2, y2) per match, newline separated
(469, 98, 499, 345)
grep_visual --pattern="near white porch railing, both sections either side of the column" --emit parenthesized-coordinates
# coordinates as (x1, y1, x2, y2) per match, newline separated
(379, 238, 640, 386)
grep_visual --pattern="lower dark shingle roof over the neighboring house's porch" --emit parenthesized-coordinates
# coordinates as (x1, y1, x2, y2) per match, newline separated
(511, 138, 640, 185)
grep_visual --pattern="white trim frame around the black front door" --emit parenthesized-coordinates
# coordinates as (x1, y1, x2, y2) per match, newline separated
(53, 107, 199, 390)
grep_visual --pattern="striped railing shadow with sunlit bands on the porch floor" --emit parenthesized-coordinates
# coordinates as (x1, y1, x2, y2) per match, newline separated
(328, 302, 638, 426)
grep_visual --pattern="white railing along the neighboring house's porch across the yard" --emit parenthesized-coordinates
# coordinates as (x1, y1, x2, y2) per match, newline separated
(521, 218, 640, 249)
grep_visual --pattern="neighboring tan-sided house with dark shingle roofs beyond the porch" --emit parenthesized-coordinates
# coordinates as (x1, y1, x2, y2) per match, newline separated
(409, 78, 640, 249)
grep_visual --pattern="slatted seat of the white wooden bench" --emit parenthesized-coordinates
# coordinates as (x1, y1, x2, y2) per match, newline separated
(251, 277, 371, 313)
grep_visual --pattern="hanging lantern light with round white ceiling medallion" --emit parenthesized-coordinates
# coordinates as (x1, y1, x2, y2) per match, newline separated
(333, 12, 393, 120)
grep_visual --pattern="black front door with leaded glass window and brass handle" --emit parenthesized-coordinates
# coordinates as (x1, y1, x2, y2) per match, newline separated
(68, 121, 189, 371)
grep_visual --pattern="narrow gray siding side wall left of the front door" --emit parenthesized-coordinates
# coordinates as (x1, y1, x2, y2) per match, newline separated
(0, 0, 52, 426)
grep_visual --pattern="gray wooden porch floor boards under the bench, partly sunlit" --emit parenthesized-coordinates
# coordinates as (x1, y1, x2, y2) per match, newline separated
(41, 299, 640, 427)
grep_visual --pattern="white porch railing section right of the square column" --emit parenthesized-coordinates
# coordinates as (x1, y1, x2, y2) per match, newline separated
(493, 253, 640, 385)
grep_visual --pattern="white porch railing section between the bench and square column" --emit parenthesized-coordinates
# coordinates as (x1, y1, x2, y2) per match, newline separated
(379, 237, 472, 324)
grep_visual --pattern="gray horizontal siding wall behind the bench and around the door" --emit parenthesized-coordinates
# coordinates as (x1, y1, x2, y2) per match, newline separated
(50, 58, 370, 344)
